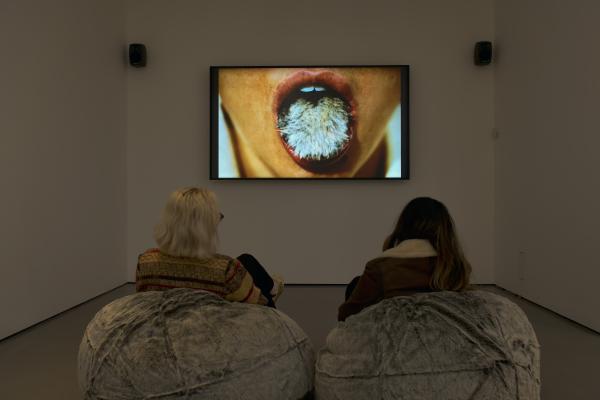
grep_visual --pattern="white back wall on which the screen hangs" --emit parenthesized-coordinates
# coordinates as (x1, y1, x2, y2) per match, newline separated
(127, 0, 494, 283)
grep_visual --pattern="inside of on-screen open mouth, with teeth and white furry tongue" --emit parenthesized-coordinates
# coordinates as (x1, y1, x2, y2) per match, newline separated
(277, 86, 350, 161)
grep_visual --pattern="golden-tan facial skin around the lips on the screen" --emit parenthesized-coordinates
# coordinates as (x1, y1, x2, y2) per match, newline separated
(219, 67, 401, 178)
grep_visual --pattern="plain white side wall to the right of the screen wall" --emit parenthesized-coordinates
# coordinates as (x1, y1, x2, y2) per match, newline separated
(495, 0, 600, 330)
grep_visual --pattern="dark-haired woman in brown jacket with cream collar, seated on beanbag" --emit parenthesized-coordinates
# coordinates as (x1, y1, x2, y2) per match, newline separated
(338, 197, 471, 321)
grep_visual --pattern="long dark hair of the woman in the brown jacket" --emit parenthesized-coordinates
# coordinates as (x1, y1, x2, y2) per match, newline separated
(383, 197, 471, 291)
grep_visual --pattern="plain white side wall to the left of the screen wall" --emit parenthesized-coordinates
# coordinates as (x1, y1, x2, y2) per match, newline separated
(0, 0, 126, 338)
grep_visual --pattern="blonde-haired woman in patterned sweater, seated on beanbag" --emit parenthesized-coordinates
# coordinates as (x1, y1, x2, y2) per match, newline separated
(136, 187, 283, 307)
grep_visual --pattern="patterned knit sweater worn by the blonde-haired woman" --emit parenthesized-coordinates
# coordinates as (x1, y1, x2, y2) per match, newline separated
(136, 249, 267, 305)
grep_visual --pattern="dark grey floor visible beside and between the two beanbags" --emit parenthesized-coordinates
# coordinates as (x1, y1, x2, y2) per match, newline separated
(0, 285, 600, 400)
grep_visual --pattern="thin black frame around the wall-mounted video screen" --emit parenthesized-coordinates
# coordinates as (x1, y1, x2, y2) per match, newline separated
(209, 65, 410, 181)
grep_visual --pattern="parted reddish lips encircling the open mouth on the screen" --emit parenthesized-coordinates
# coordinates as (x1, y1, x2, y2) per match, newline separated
(273, 70, 356, 172)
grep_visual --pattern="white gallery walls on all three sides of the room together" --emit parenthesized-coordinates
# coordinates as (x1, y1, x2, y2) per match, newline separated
(0, 0, 600, 338)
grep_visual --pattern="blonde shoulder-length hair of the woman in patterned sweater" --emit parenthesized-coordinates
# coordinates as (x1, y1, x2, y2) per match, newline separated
(154, 187, 220, 258)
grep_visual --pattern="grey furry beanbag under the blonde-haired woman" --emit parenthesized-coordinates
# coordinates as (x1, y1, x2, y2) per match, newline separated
(79, 289, 314, 400)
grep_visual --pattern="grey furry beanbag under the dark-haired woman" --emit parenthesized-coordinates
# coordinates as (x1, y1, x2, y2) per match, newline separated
(315, 291, 540, 400)
